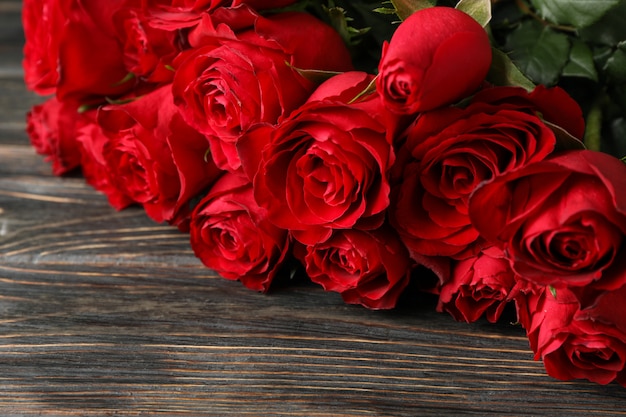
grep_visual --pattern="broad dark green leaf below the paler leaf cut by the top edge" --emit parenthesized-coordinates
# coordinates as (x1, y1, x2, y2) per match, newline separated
(506, 20, 571, 86)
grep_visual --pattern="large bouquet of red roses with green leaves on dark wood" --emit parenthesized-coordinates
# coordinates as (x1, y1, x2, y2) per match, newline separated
(23, 0, 626, 386)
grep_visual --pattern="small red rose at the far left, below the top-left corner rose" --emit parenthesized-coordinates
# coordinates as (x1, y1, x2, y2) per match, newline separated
(26, 97, 87, 175)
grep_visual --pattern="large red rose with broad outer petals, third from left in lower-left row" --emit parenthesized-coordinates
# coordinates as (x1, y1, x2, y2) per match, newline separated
(98, 85, 219, 228)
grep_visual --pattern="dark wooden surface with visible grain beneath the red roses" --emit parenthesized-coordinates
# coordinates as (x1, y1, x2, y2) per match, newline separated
(0, 0, 626, 417)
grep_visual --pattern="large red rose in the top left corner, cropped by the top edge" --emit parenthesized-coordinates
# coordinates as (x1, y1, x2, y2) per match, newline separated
(23, 0, 134, 104)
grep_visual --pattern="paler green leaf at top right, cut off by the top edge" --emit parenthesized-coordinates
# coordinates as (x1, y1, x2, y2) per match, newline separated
(531, 0, 620, 28)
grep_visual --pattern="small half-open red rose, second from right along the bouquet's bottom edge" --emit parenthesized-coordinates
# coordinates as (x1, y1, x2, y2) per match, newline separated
(437, 247, 515, 323)
